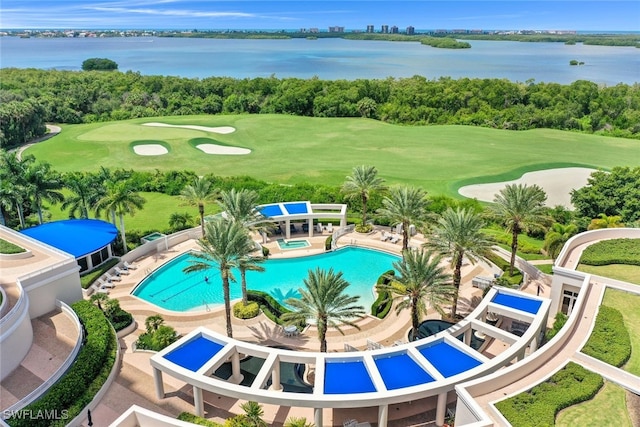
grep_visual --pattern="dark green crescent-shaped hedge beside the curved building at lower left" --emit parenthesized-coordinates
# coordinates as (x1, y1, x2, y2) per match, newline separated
(7, 301, 117, 427)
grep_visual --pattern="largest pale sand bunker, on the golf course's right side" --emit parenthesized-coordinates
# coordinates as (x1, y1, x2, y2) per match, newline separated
(458, 168, 596, 209)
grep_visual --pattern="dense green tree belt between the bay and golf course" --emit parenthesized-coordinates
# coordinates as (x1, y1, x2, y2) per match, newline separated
(0, 68, 640, 148)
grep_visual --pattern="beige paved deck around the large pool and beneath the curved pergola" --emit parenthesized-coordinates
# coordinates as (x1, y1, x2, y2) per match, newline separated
(84, 231, 536, 426)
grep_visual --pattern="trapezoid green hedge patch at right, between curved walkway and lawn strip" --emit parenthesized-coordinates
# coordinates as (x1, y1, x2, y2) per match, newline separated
(582, 305, 631, 368)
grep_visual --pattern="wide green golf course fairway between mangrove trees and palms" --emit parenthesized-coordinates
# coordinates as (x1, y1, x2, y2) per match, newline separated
(27, 115, 640, 196)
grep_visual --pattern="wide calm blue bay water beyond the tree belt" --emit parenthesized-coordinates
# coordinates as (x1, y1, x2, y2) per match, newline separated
(0, 37, 640, 85)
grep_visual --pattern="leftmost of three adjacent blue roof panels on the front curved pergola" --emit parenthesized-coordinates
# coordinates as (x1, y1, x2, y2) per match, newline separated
(324, 360, 376, 394)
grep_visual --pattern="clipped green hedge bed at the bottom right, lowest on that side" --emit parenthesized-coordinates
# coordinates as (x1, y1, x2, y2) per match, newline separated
(496, 362, 604, 427)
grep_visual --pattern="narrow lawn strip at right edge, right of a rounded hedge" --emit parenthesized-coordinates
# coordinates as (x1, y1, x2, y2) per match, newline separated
(602, 289, 640, 376)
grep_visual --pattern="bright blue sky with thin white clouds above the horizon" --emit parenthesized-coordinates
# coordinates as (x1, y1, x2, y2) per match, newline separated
(0, 0, 640, 31)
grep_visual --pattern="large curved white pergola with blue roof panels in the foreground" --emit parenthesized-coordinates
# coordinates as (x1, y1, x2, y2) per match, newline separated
(151, 287, 551, 427)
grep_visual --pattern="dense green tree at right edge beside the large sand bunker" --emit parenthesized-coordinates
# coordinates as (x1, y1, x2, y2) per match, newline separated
(571, 167, 640, 223)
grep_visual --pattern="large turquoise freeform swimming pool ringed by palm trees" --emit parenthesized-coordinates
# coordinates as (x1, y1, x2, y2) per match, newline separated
(133, 248, 400, 311)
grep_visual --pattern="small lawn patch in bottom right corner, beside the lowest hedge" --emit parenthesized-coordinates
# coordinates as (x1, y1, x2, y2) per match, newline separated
(556, 382, 633, 427)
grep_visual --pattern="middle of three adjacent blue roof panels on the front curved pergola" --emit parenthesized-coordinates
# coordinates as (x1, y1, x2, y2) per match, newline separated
(375, 353, 433, 390)
